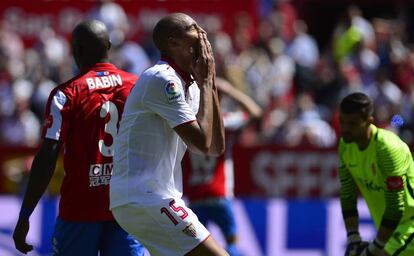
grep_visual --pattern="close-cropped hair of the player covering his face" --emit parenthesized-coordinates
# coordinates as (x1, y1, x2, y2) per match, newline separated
(152, 13, 186, 54)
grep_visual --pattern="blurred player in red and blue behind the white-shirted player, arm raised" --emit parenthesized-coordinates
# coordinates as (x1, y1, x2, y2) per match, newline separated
(183, 78, 262, 256)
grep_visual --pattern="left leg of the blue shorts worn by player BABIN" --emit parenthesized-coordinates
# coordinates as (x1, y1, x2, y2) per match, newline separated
(52, 219, 102, 256)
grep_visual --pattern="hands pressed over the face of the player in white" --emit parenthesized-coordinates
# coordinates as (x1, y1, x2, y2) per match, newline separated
(193, 27, 216, 85)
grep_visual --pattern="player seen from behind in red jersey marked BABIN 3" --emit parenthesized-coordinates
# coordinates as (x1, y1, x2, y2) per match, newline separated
(13, 20, 144, 255)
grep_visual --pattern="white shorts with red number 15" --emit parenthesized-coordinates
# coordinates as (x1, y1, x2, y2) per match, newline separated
(112, 198, 210, 256)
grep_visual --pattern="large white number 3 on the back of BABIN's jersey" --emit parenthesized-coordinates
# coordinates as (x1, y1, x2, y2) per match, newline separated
(98, 101, 118, 157)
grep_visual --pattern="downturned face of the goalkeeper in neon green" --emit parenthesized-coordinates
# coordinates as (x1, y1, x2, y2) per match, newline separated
(339, 112, 371, 143)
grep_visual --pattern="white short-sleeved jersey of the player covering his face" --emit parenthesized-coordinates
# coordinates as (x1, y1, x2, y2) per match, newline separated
(110, 61, 200, 209)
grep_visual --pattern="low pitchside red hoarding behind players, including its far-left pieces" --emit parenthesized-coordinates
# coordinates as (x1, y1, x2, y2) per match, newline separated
(0, 146, 339, 198)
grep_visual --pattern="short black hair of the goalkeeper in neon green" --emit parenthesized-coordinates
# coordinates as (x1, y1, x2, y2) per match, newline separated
(340, 92, 374, 119)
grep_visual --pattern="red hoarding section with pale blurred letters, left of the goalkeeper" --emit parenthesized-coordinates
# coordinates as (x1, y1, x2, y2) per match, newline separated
(233, 146, 340, 198)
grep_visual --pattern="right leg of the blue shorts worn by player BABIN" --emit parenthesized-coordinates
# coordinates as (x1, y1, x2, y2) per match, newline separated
(100, 221, 145, 256)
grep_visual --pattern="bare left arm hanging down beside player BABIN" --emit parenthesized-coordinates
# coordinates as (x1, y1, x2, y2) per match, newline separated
(13, 139, 62, 253)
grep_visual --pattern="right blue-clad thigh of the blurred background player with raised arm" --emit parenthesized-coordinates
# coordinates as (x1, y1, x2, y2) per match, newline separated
(211, 199, 236, 239)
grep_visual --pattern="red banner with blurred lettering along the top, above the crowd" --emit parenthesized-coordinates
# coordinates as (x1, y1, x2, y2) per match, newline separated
(0, 0, 258, 45)
